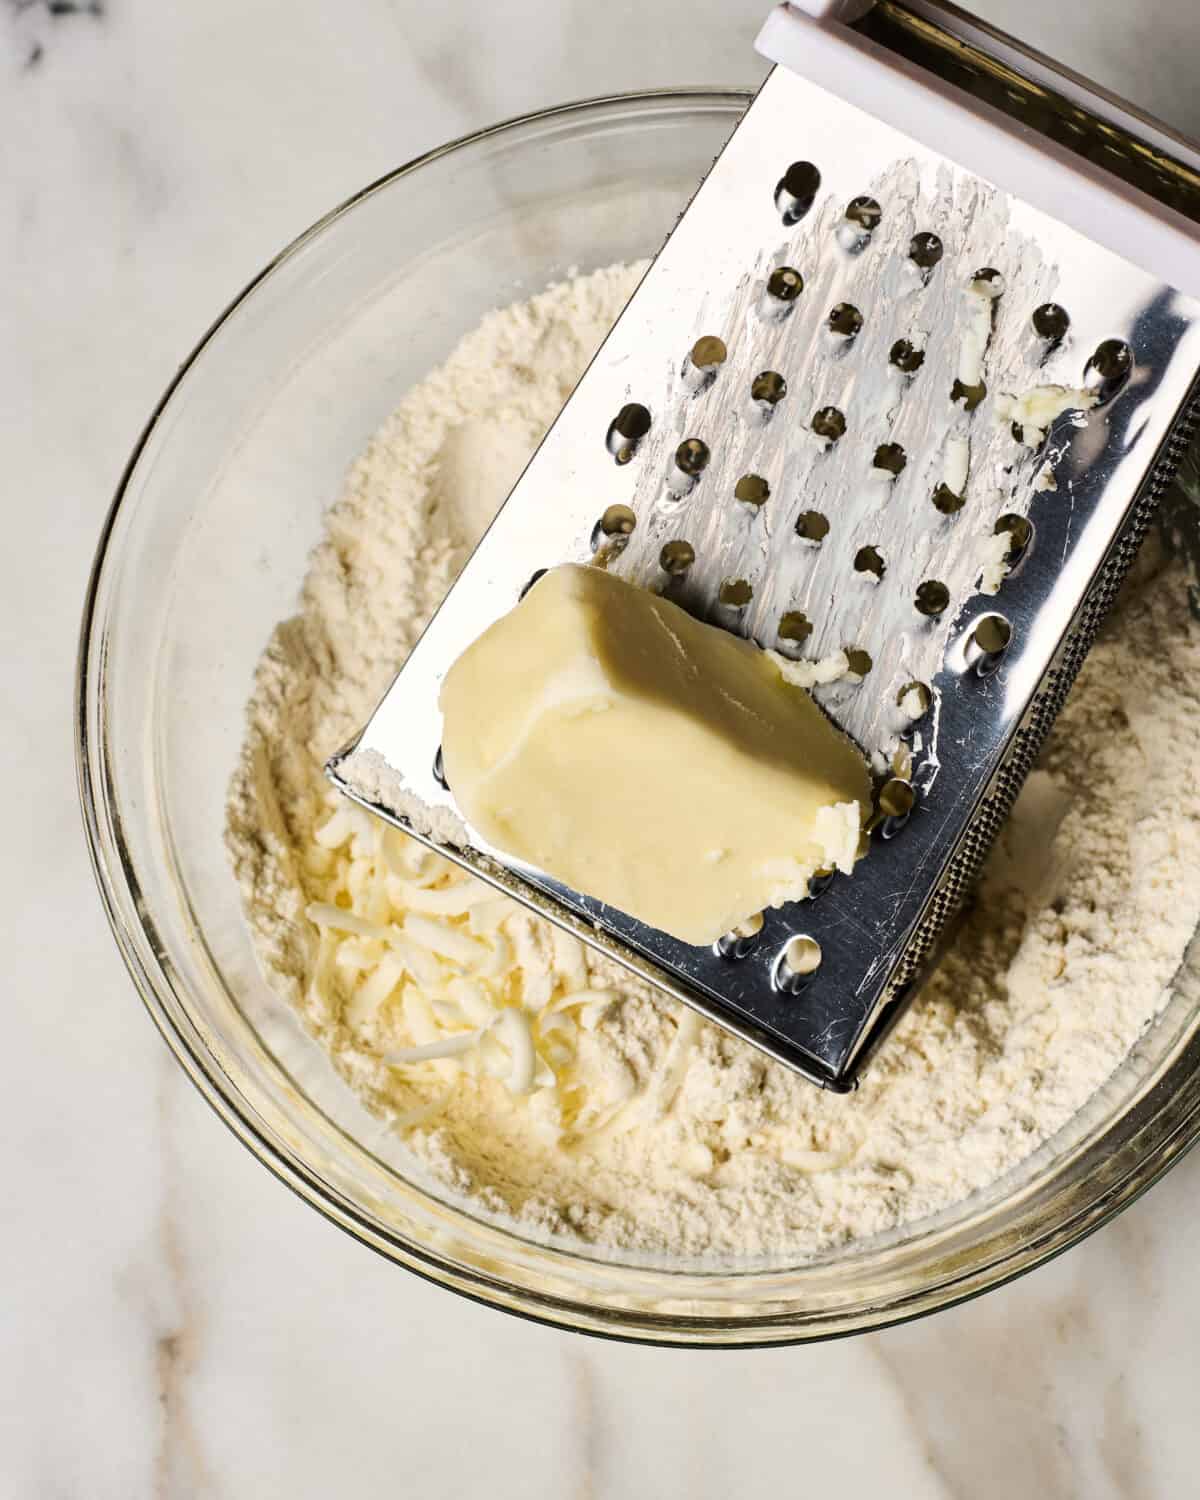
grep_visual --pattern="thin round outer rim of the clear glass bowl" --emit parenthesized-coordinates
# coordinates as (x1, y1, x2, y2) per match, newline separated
(74, 86, 1200, 1349)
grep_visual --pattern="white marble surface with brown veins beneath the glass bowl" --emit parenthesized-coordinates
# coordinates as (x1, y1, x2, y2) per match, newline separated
(0, 0, 1200, 1500)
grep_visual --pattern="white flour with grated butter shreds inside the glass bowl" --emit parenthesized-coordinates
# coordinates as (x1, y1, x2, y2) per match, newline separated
(228, 269, 1200, 1256)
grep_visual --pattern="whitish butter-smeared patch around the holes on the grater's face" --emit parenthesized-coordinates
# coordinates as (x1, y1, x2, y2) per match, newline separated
(609, 159, 1062, 756)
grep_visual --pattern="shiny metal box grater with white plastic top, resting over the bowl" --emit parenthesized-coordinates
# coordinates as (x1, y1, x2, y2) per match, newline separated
(329, 3, 1200, 1089)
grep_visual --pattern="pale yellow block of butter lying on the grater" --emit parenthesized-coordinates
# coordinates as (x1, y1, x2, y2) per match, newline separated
(440, 566, 870, 944)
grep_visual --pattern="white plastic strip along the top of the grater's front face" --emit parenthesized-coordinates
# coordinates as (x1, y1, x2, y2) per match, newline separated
(756, 0, 1200, 299)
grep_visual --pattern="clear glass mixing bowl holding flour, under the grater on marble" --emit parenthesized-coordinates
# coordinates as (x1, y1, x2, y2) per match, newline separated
(78, 90, 1200, 1346)
